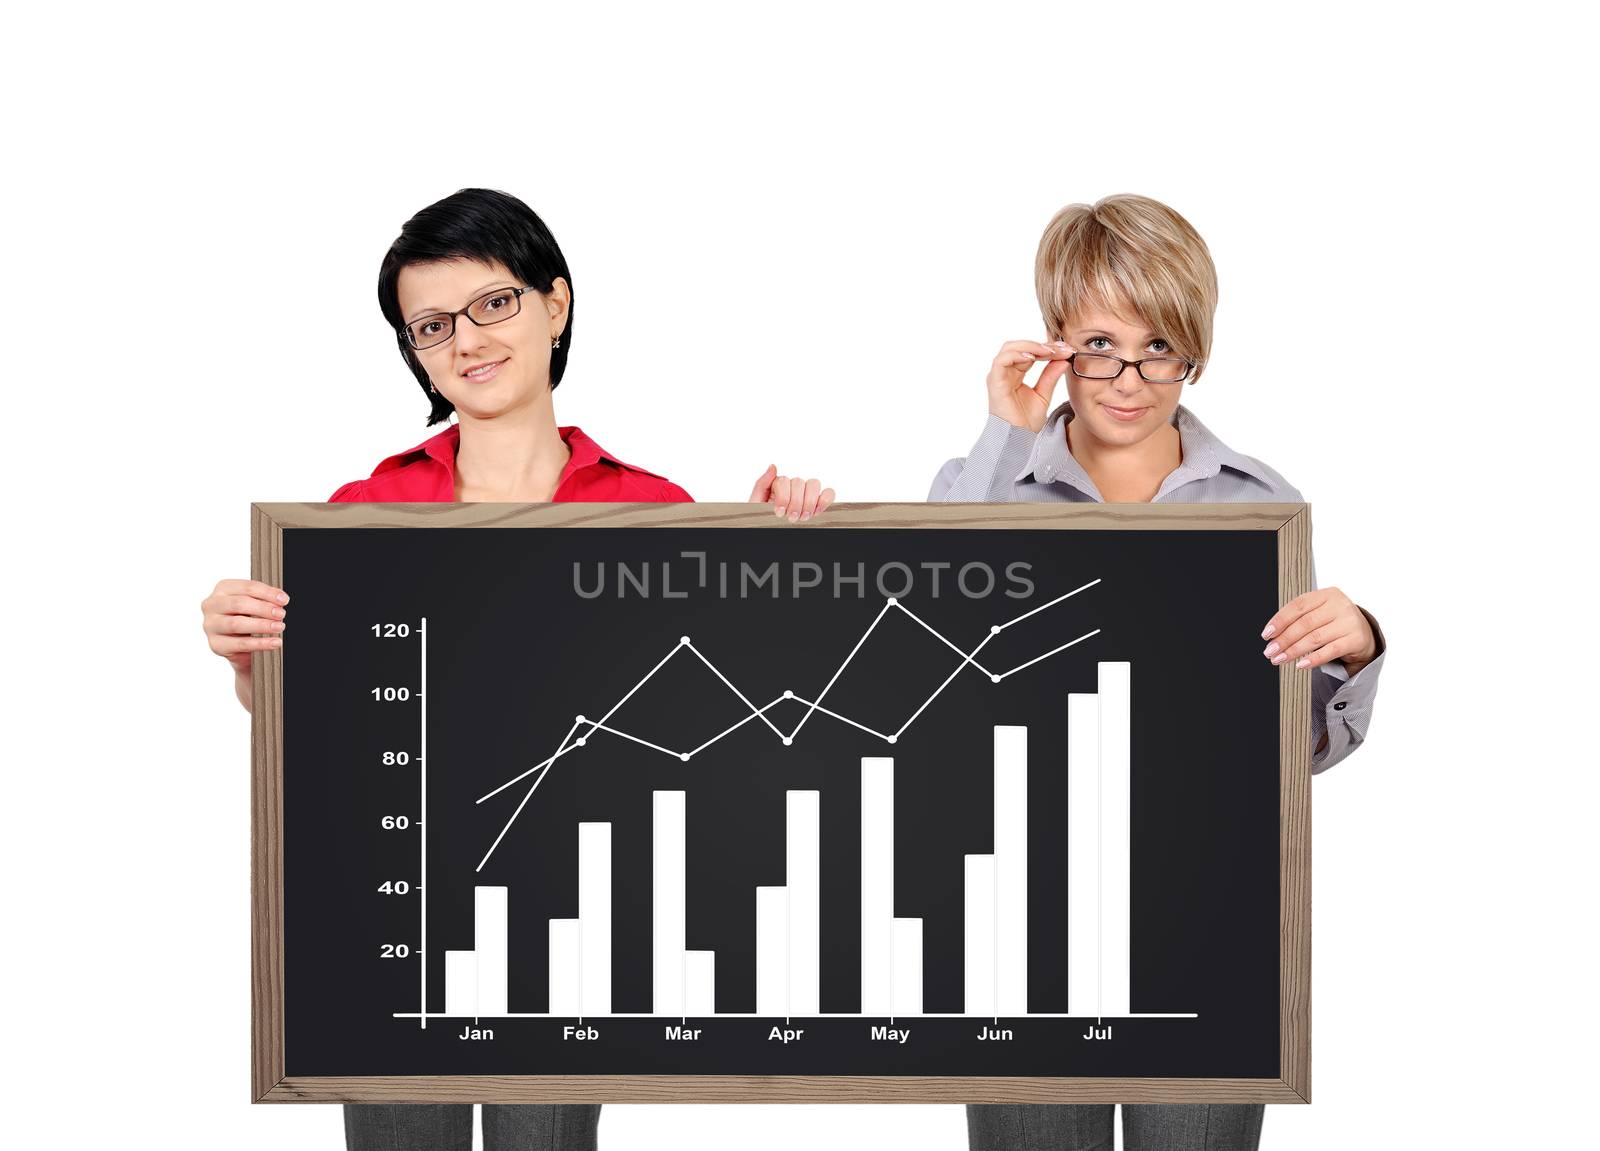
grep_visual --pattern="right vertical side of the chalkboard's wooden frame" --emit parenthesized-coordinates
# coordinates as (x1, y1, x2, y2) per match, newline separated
(1278, 504, 1322, 1103)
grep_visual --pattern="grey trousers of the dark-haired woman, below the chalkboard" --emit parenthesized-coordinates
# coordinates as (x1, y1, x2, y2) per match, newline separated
(344, 1103, 600, 1151)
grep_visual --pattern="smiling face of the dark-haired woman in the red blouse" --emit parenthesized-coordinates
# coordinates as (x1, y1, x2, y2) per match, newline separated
(397, 259, 568, 419)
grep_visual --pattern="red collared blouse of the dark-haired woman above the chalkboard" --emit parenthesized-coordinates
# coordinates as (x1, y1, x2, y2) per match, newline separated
(328, 424, 693, 504)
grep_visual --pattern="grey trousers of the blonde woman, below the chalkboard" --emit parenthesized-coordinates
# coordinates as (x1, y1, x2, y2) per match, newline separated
(966, 1103, 1267, 1151)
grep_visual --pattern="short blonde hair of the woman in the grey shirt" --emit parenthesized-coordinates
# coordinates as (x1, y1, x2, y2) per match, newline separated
(1034, 194, 1216, 379)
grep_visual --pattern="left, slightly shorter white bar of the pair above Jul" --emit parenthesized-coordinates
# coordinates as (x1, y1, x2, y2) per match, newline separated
(1067, 692, 1104, 1015)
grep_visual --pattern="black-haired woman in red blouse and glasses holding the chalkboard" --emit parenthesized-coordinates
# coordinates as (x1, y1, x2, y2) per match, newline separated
(200, 189, 834, 1151)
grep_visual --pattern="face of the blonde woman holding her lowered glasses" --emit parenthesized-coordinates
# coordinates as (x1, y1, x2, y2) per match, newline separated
(1061, 311, 1184, 447)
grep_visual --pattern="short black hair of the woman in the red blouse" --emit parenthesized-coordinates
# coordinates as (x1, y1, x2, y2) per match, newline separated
(378, 187, 573, 427)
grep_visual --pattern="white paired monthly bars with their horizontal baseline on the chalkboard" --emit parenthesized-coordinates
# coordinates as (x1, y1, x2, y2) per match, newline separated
(406, 663, 1195, 1021)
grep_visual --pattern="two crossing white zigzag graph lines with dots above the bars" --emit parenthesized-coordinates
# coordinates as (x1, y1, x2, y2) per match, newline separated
(474, 578, 1101, 871)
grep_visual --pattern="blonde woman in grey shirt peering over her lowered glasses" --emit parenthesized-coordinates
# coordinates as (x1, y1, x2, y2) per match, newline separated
(928, 195, 1386, 1151)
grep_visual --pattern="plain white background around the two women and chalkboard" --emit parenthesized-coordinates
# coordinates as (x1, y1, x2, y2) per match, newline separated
(0, 3, 1600, 1149)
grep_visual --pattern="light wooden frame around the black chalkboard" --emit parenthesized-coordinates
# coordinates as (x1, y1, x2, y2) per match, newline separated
(250, 503, 1312, 1103)
